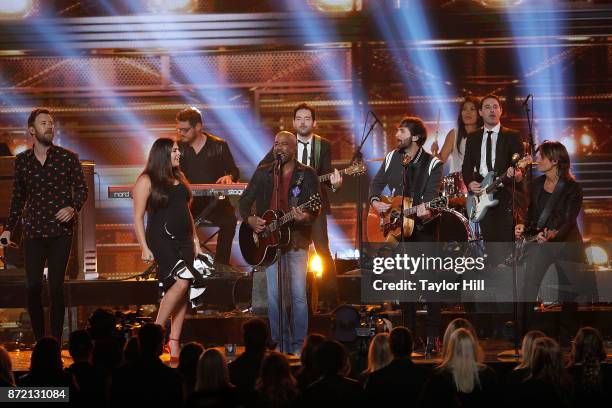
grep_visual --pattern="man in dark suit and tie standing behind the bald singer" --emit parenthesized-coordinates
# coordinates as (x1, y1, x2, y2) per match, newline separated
(259, 103, 342, 309)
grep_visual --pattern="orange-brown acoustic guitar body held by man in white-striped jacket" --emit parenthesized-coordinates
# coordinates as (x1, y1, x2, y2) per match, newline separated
(367, 196, 414, 243)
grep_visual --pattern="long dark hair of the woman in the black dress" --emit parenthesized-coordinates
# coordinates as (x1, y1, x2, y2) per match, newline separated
(142, 137, 191, 212)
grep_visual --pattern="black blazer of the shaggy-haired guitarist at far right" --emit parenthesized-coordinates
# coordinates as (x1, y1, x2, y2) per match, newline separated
(525, 176, 582, 242)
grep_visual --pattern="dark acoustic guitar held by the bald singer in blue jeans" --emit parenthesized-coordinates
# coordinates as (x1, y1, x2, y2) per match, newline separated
(238, 193, 321, 266)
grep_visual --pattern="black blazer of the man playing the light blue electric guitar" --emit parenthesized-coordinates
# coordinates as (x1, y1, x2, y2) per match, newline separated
(461, 126, 525, 186)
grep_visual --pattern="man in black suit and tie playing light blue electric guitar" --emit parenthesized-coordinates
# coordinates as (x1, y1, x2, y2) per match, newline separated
(462, 95, 524, 242)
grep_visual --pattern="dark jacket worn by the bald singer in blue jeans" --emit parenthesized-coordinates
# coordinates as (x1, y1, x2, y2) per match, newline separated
(238, 161, 321, 248)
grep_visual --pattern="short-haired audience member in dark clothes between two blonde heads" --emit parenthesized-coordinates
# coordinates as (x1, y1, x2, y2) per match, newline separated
(365, 326, 430, 407)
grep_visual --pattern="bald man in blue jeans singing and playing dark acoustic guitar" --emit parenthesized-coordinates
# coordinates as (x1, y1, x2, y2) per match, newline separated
(239, 131, 321, 354)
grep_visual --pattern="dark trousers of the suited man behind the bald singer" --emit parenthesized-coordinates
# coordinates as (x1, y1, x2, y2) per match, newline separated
(311, 213, 338, 307)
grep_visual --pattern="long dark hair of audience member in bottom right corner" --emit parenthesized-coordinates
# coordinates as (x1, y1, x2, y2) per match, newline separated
(572, 327, 606, 391)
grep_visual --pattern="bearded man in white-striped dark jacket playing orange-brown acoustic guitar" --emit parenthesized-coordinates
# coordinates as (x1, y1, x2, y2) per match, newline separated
(370, 116, 443, 344)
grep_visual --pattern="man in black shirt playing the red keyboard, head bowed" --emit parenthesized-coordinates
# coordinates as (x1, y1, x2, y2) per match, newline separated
(176, 107, 240, 265)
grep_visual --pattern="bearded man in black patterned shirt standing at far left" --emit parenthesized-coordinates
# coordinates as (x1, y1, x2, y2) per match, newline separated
(0, 109, 87, 342)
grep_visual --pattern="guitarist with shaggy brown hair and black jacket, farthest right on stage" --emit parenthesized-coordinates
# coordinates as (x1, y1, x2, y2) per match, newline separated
(514, 141, 584, 344)
